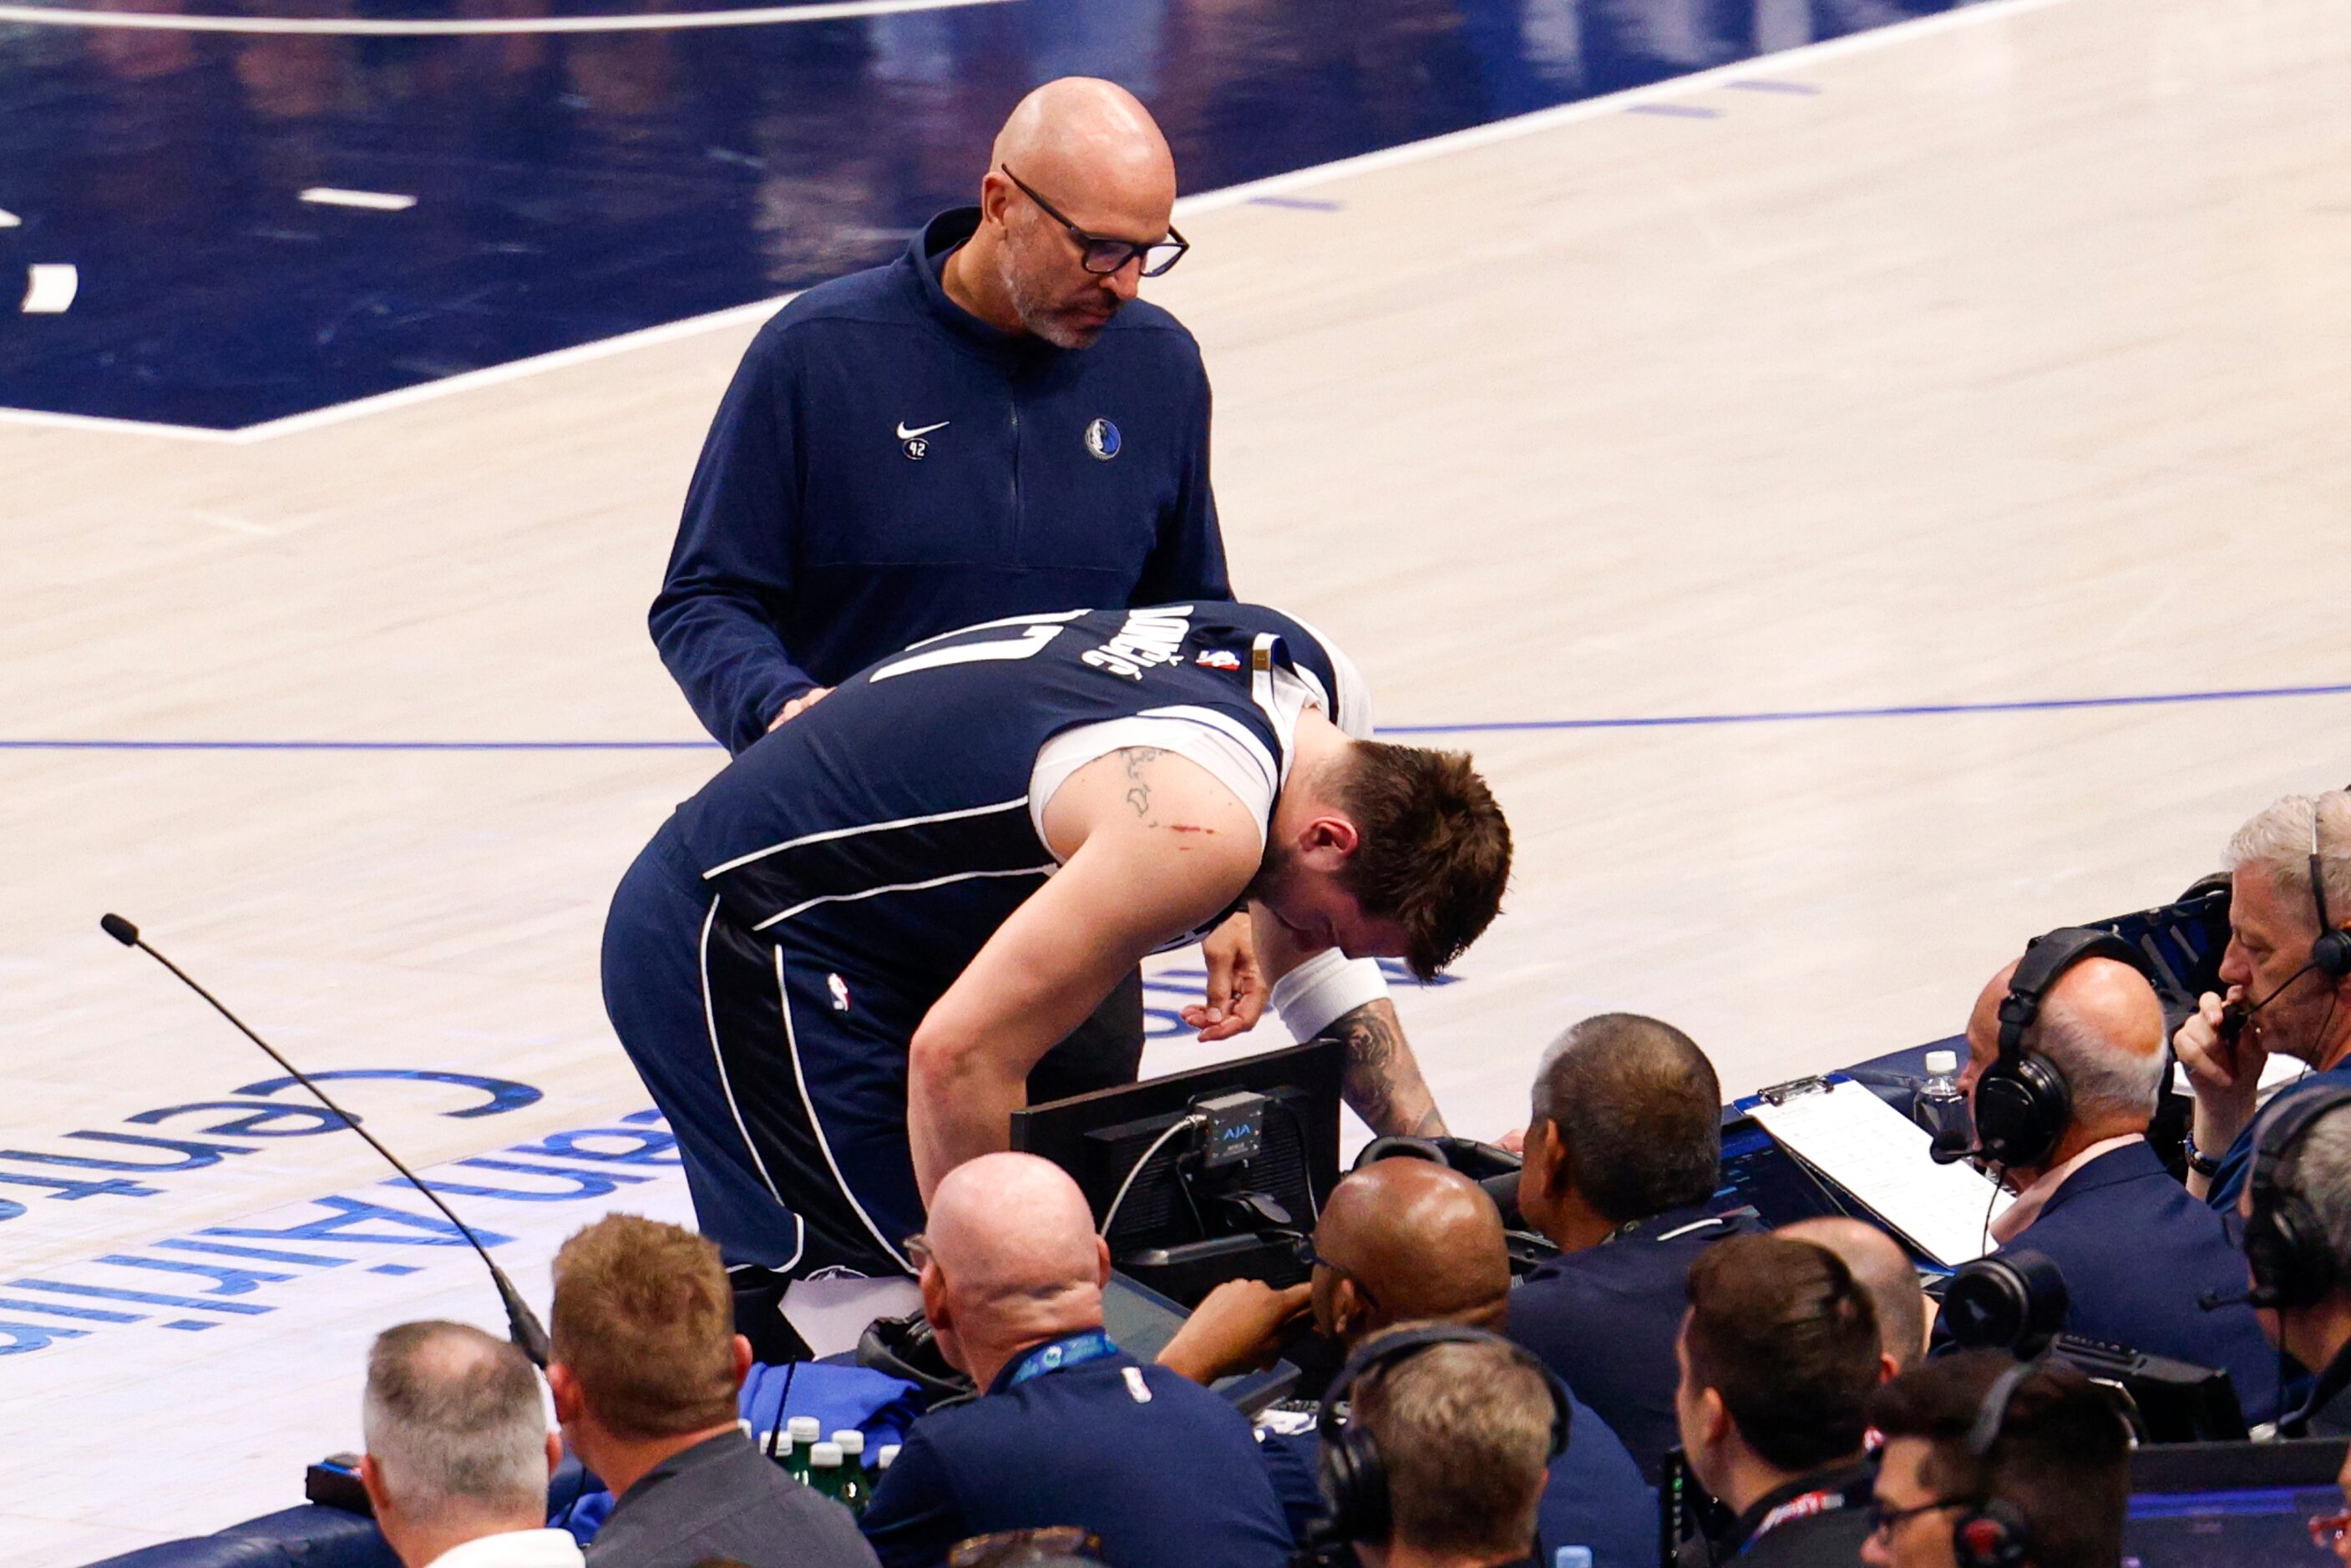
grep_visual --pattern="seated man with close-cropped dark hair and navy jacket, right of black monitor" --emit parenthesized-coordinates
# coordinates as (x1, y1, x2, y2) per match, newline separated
(1502, 1014, 1759, 1484)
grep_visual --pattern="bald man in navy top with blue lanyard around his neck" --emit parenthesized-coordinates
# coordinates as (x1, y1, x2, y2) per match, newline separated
(863, 1154, 1290, 1568)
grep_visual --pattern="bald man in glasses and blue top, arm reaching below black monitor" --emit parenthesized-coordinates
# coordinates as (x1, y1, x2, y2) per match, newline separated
(1159, 1159, 1658, 1568)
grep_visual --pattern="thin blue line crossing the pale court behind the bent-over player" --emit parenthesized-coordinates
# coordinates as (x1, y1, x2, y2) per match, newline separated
(0, 682, 2351, 752)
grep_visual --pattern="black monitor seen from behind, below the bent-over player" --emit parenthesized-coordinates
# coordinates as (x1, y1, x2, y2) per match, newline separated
(1011, 1039, 1345, 1267)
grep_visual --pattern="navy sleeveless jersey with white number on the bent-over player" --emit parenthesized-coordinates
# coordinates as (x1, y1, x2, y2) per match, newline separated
(672, 602, 1368, 978)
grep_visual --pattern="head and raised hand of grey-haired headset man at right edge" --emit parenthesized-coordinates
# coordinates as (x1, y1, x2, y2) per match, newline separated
(2172, 790, 2351, 1213)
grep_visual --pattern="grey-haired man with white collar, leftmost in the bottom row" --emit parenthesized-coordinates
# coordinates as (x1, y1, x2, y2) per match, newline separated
(360, 1321, 583, 1568)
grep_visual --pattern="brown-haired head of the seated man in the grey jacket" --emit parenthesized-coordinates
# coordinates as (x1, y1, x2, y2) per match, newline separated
(548, 1213, 736, 1439)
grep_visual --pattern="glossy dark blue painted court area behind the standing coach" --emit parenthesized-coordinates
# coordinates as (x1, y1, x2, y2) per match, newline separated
(0, 0, 1956, 430)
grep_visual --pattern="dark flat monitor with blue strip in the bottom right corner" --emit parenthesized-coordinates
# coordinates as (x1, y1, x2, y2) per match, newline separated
(2123, 1439, 2344, 1568)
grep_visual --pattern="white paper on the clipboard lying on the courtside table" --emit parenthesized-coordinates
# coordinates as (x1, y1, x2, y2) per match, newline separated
(1742, 1075, 2013, 1269)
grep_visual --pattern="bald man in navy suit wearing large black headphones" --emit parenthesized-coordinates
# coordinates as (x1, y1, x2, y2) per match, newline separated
(1938, 933, 2278, 1422)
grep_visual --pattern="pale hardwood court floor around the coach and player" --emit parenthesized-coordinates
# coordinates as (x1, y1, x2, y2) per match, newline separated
(0, 0, 2351, 1563)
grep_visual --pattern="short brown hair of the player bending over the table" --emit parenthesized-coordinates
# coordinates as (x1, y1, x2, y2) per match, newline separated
(1335, 741, 1509, 980)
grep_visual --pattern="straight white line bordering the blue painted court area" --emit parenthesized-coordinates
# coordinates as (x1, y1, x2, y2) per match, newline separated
(0, 0, 2065, 447)
